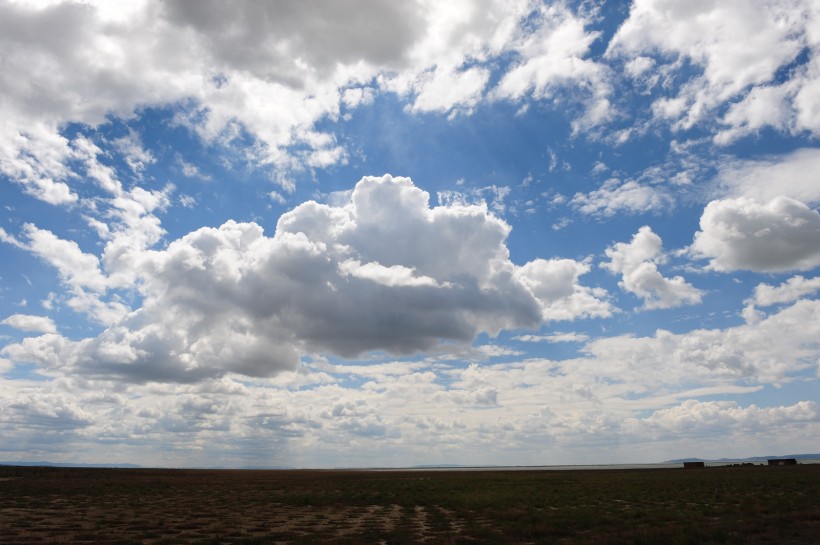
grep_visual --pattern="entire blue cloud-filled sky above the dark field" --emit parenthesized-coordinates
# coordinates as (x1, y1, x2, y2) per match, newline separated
(0, 0, 820, 468)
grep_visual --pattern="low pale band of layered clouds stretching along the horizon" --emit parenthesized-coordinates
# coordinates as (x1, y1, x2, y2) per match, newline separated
(0, 301, 820, 467)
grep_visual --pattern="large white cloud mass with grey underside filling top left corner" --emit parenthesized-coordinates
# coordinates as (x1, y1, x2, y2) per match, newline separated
(0, 0, 406, 200)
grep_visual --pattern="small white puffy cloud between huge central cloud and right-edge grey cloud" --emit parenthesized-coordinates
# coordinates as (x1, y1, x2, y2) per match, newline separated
(601, 226, 702, 309)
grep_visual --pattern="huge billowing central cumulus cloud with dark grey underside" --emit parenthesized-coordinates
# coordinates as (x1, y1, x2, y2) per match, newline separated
(3, 175, 610, 381)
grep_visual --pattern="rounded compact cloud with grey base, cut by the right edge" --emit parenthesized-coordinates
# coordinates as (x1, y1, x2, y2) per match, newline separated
(690, 197, 820, 272)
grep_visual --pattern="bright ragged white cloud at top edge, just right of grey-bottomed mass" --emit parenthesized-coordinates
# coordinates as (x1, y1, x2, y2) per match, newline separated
(379, 0, 612, 122)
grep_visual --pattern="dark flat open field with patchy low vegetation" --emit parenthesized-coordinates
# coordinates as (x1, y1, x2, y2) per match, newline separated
(0, 465, 820, 545)
